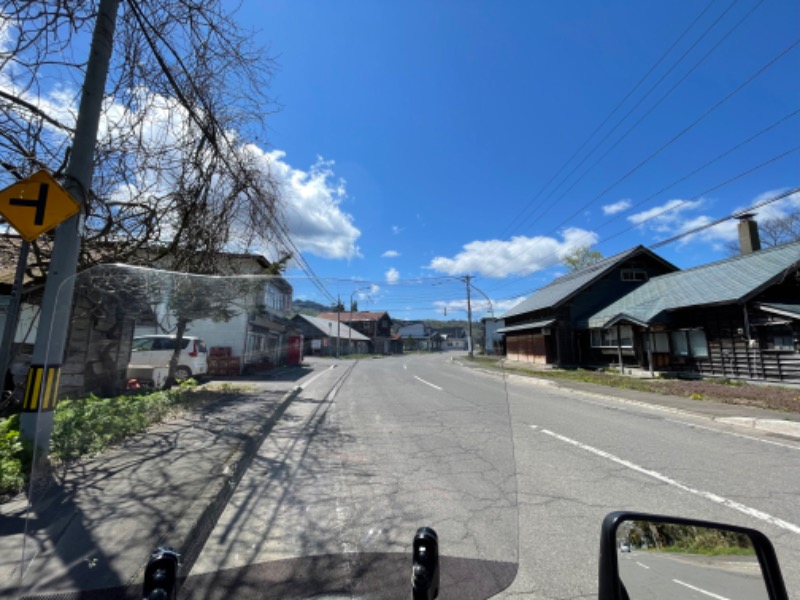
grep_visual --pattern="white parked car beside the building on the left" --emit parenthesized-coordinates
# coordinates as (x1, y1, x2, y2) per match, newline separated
(128, 335, 208, 381)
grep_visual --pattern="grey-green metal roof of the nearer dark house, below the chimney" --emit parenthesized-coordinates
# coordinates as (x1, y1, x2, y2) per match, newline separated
(588, 242, 800, 328)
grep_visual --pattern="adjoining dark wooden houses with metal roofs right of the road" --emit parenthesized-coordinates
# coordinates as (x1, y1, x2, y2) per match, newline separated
(494, 215, 800, 382)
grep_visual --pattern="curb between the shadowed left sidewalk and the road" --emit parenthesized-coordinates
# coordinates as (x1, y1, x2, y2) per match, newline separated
(171, 387, 301, 588)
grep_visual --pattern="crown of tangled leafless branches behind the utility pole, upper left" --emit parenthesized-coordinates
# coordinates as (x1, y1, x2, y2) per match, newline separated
(0, 0, 286, 274)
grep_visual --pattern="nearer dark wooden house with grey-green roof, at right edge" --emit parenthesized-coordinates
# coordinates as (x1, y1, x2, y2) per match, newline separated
(588, 242, 800, 382)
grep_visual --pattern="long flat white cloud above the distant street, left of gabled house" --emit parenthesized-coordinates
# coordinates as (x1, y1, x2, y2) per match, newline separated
(428, 227, 599, 278)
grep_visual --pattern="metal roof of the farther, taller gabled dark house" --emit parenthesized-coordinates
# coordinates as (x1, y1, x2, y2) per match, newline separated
(503, 246, 676, 319)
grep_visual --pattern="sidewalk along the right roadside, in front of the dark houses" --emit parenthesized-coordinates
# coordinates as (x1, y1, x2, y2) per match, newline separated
(458, 360, 800, 440)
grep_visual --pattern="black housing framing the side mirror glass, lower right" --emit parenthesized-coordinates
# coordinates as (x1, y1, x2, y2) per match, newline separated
(597, 512, 789, 600)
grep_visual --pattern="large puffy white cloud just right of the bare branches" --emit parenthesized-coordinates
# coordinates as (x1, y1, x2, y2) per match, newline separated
(249, 146, 361, 259)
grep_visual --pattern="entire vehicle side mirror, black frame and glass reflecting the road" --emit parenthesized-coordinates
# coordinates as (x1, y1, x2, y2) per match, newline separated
(598, 512, 789, 600)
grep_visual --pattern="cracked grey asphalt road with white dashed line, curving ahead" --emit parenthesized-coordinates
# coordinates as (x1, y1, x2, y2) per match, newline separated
(187, 355, 800, 598)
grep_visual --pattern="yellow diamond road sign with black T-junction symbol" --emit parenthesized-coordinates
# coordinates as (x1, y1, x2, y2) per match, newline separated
(0, 171, 81, 242)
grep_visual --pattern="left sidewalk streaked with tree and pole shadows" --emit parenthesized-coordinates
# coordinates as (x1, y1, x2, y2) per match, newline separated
(0, 377, 299, 598)
